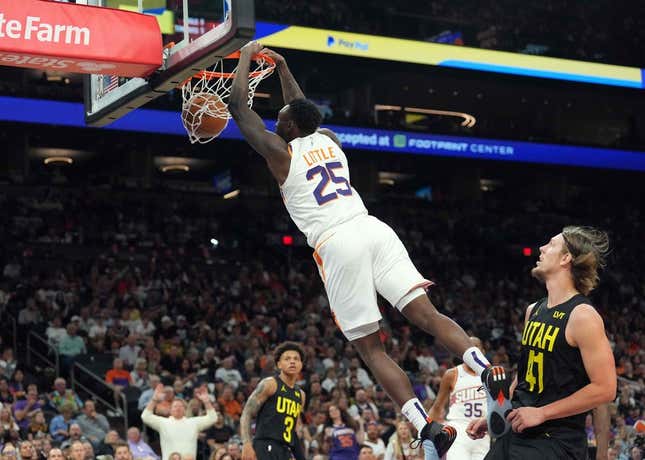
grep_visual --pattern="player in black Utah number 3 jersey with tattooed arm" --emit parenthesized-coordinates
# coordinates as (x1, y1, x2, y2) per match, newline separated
(240, 342, 305, 460)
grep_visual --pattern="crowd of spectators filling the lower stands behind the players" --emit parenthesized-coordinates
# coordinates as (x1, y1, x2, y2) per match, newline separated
(0, 187, 645, 460)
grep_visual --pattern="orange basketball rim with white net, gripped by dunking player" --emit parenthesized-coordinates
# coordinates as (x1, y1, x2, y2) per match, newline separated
(179, 51, 275, 144)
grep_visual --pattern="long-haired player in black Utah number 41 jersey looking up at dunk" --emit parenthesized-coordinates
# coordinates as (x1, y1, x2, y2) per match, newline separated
(468, 227, 616, 460)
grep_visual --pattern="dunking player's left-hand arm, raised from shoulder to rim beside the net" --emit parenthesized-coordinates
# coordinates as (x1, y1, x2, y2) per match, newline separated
(228, 42, 291, 183)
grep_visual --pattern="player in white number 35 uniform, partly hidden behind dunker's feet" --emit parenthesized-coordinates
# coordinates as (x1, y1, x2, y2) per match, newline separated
(426, 337, 490, 460)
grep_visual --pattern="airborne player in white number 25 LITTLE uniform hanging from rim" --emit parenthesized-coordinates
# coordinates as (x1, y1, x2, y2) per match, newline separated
(228, 42, 510, 453)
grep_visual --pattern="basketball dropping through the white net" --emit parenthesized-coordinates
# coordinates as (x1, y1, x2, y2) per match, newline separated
(181, 93, 228, 139)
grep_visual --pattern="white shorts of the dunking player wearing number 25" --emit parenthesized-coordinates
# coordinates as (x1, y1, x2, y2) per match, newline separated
(314, 215, 432, 340)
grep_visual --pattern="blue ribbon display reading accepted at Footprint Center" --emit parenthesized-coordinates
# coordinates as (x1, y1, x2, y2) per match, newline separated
(0, 96, 645, 171)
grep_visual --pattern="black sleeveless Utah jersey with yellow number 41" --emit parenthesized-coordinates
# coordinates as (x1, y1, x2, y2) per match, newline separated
(513, 294, 591, 452)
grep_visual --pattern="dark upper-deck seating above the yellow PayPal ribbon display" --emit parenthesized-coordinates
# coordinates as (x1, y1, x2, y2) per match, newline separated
(257, 0, 645, 67)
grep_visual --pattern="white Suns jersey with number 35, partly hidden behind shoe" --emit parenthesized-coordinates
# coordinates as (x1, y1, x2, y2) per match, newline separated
(447, 364, 486, 427)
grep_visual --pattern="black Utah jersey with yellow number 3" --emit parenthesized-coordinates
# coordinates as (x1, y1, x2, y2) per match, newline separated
(255, 376, 302, 446)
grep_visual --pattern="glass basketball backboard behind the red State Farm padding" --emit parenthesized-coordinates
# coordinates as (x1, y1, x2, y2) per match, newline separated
(84, 0, 255, 127)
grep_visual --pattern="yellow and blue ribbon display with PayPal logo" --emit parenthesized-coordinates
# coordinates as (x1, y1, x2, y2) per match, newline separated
(255, 22, 645, 88)
